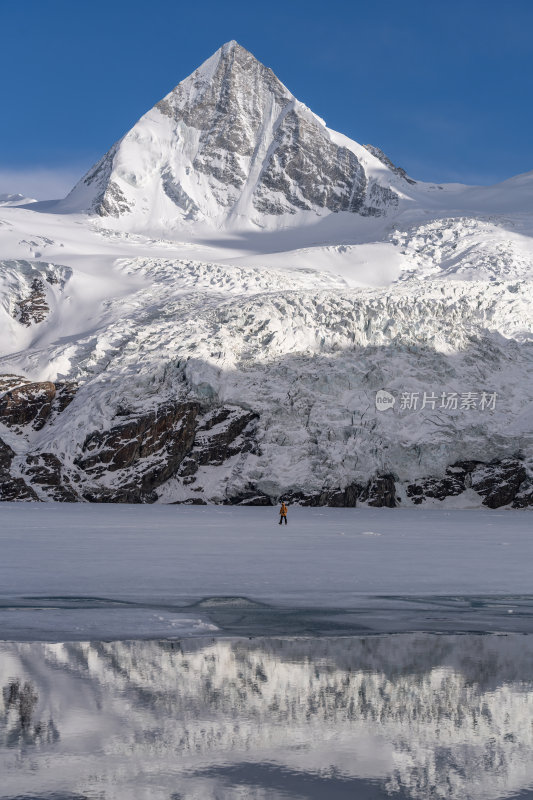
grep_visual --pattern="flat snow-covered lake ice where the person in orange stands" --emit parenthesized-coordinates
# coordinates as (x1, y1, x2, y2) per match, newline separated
(0, 503, 533, 641)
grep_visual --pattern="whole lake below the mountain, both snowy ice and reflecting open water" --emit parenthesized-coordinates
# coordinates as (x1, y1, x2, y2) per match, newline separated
(0, 504, 533, 800)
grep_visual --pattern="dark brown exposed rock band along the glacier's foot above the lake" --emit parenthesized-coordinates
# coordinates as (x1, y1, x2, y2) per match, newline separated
(0, 375, 533, 508)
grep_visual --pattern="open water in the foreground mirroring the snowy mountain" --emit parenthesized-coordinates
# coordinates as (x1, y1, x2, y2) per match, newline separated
(0, 634, 533, 800)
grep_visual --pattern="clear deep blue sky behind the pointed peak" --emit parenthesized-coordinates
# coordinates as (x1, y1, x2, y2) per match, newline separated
(0, 0, 533, 198)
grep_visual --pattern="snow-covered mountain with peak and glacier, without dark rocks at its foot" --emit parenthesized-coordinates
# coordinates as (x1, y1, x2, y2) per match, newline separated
(0, 42, 533, 504)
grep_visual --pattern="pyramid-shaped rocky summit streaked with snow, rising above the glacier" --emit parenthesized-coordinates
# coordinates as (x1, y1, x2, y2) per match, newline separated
(60, 41, 404, 229)
